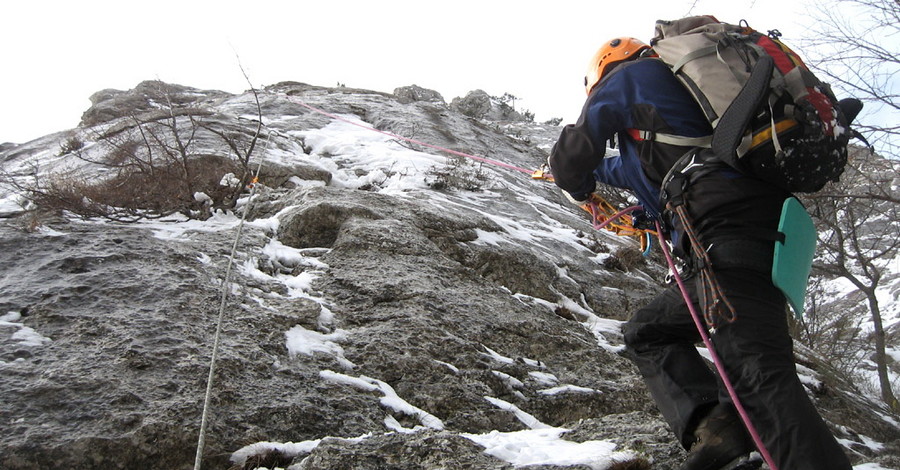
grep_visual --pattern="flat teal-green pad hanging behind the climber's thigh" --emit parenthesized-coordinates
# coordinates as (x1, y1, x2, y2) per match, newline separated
(772, 197, 817, 318)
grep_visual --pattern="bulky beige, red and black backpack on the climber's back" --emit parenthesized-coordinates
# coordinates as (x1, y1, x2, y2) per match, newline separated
(651, 16, 861, 193)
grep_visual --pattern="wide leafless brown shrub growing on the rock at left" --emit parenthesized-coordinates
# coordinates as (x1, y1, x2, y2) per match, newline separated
(9, 78, 262, 222)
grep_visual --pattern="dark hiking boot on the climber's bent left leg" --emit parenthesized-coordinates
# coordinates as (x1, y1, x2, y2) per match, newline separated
(680, 403, 762, 470)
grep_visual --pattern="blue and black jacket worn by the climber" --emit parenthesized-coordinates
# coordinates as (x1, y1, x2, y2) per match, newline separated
(550, 58, 712, 218)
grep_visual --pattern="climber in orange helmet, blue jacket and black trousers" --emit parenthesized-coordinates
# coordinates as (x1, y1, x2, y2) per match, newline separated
(548, 38, 851, 470)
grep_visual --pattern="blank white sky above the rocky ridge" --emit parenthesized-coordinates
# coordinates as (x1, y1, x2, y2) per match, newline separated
(0, 0, 810, 143)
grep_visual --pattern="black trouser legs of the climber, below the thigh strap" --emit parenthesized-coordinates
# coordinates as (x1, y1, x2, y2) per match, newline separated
(624, 266, 851, 470)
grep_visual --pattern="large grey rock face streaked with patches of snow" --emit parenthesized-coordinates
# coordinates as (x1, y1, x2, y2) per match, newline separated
(0, 83, 900, 470)
